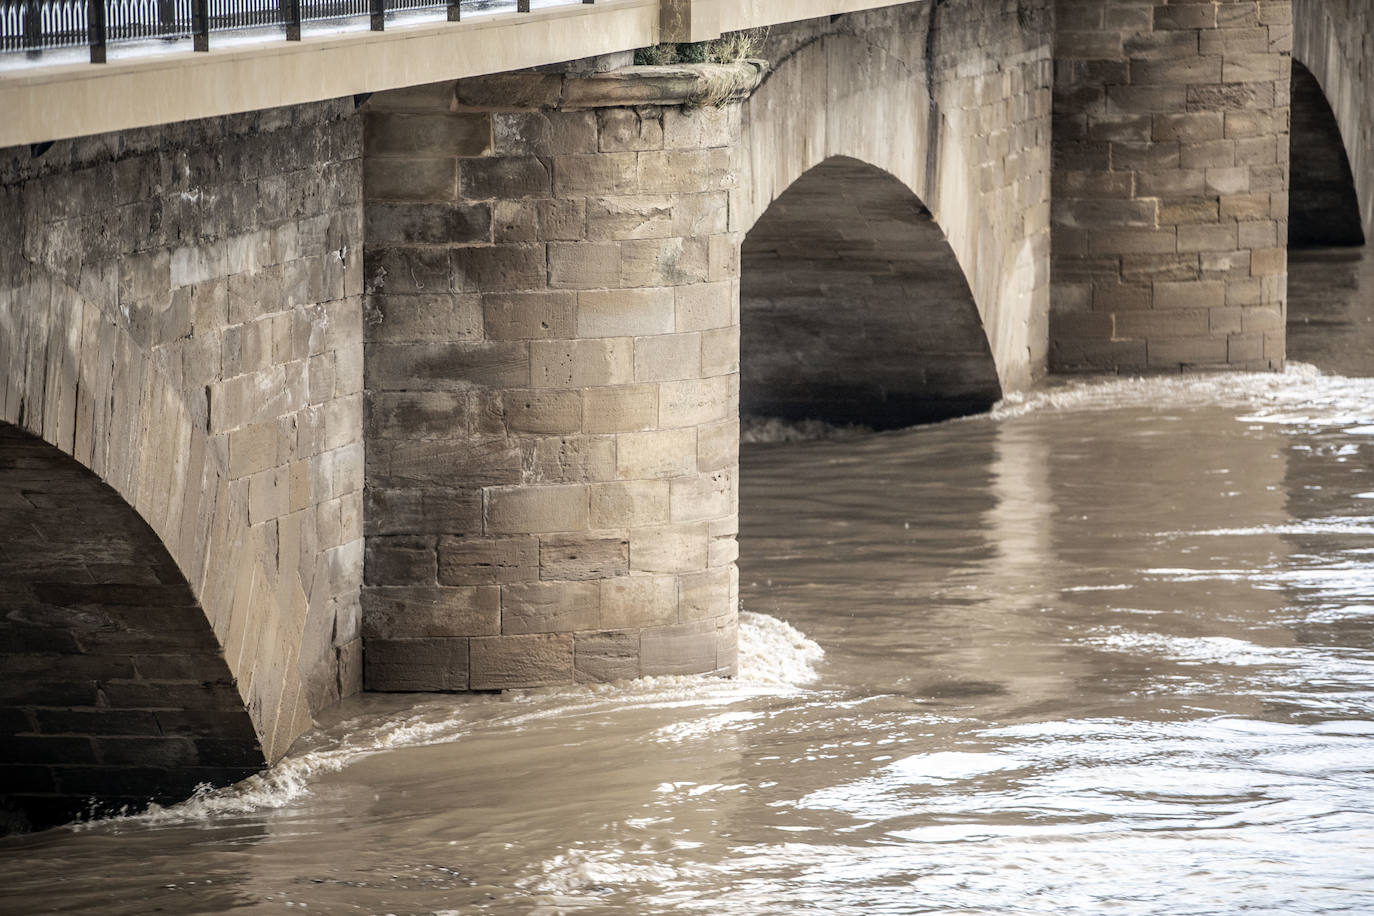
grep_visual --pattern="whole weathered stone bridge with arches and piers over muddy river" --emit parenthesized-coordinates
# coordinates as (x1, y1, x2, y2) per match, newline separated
(0, 0, 1374, 824)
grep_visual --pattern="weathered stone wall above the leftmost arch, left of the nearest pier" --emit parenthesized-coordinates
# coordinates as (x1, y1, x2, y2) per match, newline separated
(0, 102, 363, 780)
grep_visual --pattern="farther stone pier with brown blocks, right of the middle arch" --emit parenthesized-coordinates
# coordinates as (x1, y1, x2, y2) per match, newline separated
(1050, 0, 1293, 372)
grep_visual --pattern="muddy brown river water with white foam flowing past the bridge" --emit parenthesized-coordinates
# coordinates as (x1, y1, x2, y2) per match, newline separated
(8, 247, 1374, 916)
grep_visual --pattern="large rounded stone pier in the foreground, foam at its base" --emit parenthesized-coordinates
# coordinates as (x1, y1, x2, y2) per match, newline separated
(363, 63, 761, 691)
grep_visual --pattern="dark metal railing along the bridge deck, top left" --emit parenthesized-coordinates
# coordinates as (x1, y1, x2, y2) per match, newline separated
(0, 0, 596, 63)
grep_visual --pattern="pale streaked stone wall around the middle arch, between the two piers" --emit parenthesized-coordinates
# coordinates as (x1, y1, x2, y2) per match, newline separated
(731, 0, 1051, 391)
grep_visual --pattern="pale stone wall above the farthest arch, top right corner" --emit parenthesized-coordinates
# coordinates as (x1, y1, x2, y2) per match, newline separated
(1293, 0, 1374, 238)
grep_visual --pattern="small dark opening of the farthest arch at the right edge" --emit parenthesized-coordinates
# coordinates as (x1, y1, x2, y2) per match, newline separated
(1289, 59, 1364, 249)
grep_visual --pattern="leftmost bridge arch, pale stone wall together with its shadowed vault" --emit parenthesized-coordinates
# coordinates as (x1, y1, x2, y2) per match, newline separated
(0, 106, 363, 824)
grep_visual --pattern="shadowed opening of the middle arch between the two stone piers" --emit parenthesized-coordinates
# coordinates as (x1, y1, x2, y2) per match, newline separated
(739, 157, 1002, 428)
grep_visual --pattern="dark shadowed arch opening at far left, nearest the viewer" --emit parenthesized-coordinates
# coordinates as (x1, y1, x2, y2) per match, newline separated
(0, 423, 265, 834)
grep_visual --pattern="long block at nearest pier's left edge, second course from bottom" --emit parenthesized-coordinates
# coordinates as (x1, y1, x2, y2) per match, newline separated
(363, 585, 502, 637)
